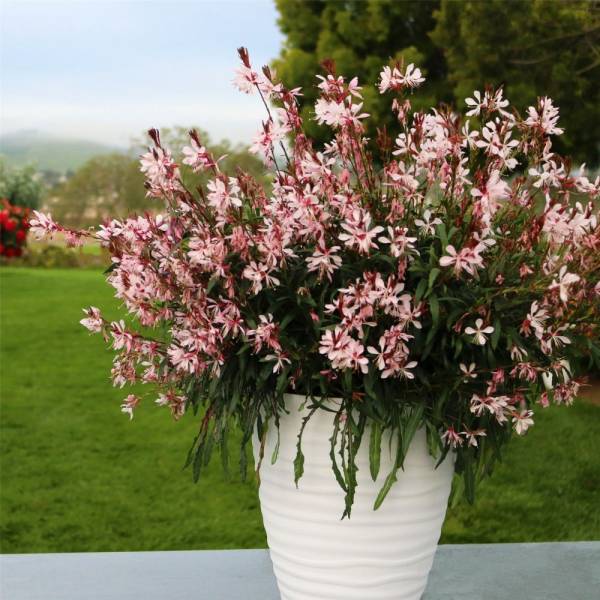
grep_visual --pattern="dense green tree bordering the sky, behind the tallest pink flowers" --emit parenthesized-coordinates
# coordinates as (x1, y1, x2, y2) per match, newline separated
(273, 0, 451, 142)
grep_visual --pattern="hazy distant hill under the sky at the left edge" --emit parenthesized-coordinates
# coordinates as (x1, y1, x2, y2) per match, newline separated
(0, 130, 126, 173)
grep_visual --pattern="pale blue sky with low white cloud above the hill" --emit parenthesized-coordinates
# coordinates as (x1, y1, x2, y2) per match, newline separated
(0, 0, 282, 147)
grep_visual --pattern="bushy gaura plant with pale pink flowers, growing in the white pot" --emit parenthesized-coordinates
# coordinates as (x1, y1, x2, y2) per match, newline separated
(32, 48, 600, 516)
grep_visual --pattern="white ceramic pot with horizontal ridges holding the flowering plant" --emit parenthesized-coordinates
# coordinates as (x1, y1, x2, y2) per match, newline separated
(253, 394, 454, 600)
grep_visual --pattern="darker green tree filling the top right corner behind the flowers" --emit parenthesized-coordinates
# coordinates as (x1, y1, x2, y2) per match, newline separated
(431, 0, 600, 163)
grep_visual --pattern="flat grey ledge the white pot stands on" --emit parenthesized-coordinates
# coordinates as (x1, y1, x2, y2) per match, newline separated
(0, 542, 600, 600)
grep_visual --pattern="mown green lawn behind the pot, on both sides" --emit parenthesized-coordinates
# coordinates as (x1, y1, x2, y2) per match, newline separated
(0, 268, 600, 552)
